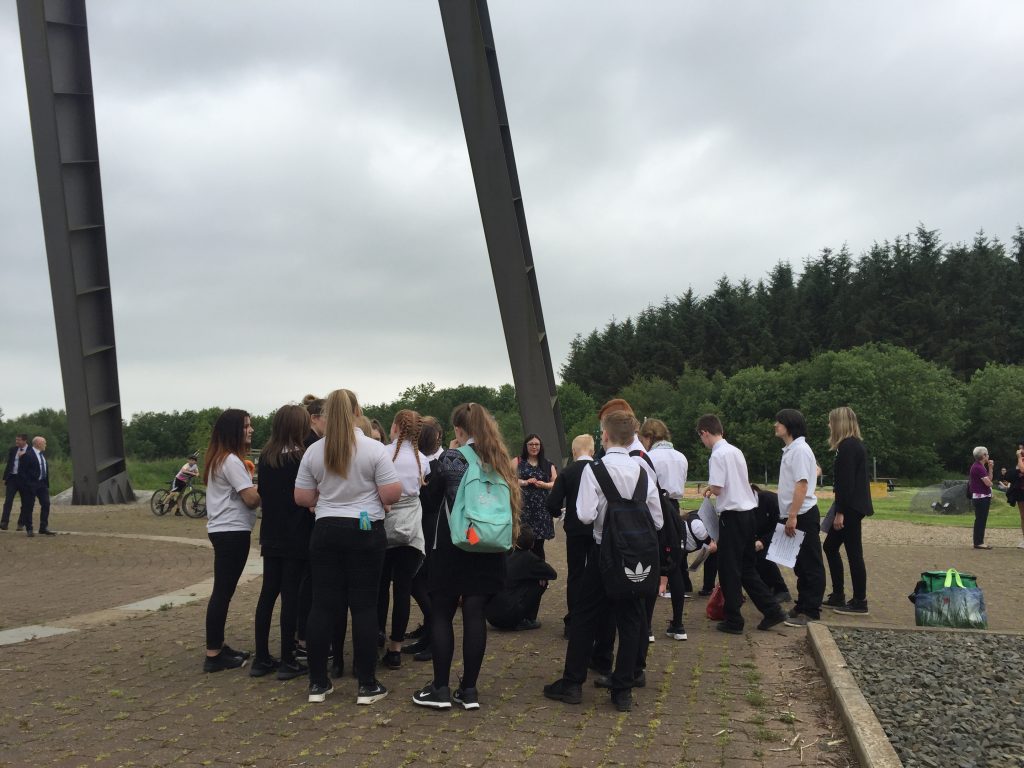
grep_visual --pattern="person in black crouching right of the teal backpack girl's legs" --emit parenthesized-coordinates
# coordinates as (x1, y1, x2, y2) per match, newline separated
(486, 525, 558, 630)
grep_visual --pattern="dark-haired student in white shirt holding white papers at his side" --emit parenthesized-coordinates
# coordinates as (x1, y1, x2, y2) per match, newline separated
(775, 408, 825, 627)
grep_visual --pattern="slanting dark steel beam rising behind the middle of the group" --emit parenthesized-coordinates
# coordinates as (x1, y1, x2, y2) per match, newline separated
(438, 0, 566, 466)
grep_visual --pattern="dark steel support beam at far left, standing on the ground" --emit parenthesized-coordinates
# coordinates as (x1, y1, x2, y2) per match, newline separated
(17, 0, 135, 504)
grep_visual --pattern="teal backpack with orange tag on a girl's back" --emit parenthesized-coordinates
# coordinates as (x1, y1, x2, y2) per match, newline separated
(449, 445, 512, 553)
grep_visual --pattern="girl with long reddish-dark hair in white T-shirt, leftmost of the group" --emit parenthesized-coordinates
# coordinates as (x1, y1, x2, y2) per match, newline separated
(203, 408, 259, 672)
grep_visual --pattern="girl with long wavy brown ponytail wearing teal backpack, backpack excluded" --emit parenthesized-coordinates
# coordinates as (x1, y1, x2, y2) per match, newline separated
(413, 402, 521, 710)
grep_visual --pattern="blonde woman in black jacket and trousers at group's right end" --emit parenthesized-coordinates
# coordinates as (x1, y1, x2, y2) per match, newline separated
(822, 406, 874, 613)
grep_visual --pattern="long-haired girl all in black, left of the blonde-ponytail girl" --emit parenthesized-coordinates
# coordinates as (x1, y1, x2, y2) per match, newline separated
(249, 406, 313, 680)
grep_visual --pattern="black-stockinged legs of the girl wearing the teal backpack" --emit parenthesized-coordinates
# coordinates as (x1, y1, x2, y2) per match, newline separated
(430, 592, 492, 689)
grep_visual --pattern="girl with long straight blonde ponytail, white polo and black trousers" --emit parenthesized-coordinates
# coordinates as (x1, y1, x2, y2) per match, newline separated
(295, 389, 401, 705)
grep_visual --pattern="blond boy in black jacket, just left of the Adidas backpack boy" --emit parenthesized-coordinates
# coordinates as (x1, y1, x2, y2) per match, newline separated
(548, 434, 598, 638)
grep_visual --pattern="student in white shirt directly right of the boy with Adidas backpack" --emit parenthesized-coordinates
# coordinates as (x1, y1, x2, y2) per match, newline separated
(640, 419, 690, 640)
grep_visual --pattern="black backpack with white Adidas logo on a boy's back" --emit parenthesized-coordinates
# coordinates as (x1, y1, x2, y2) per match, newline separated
(590, 460, 660, 600)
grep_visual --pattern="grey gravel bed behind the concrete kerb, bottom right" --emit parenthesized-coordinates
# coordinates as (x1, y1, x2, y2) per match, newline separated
(831, 627, 1024, 768)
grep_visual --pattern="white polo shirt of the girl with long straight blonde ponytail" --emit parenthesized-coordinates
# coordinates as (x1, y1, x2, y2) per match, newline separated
(295, 429, 399, 520)
